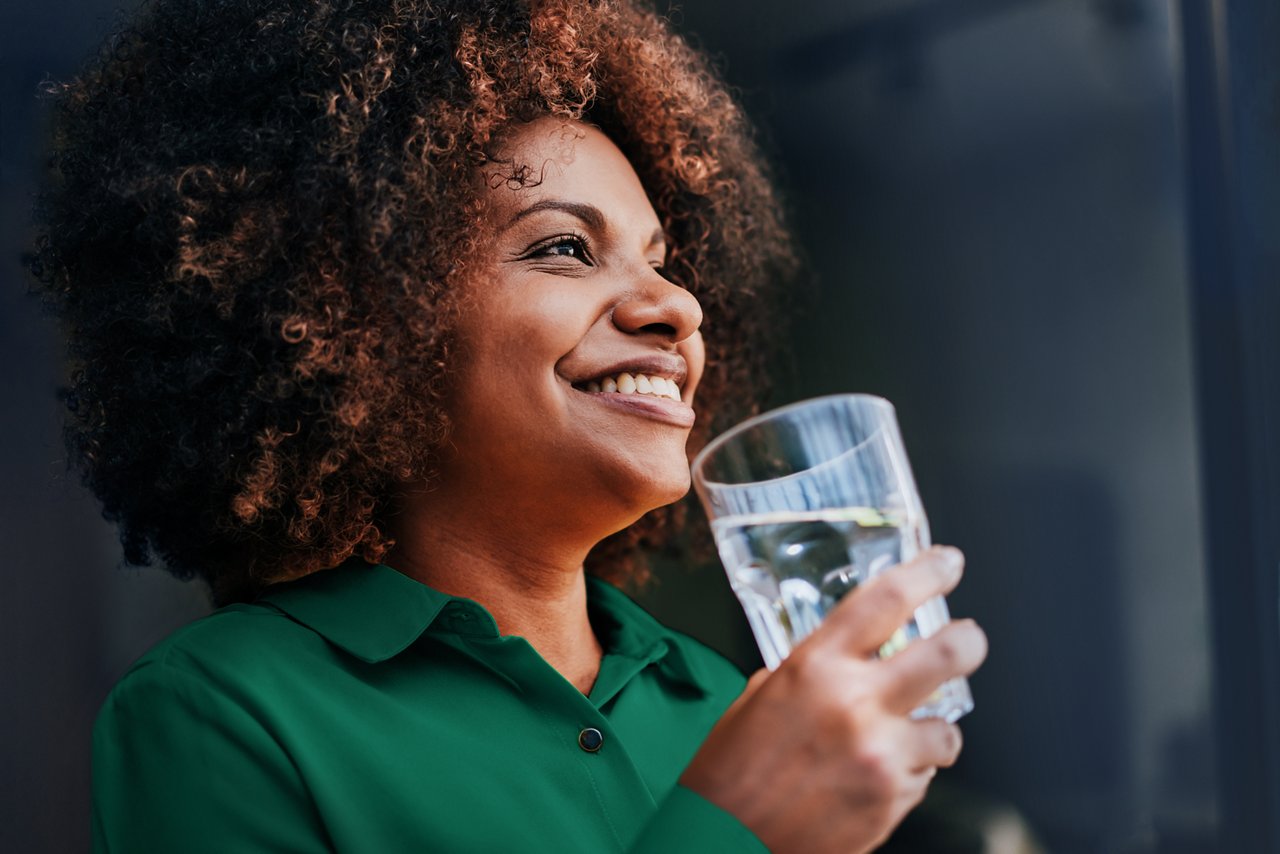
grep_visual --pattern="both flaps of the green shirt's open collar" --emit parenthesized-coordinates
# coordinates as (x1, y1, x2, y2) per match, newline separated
(254, 560, 707, 690)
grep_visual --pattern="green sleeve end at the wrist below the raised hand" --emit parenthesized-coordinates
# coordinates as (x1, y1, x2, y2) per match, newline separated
(628, 785, 768, 854)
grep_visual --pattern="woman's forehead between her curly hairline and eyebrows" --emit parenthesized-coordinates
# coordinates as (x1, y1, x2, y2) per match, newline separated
(481, 118, 658, 230)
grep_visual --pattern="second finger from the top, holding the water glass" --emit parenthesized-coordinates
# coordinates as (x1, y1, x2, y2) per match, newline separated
(882, 620, 987, 714)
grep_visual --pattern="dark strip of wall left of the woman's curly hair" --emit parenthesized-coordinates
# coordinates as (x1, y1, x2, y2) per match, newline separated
(0, 0, 205, 853)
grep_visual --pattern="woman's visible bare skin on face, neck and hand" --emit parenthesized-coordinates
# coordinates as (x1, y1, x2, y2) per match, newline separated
(388, 119, 987, 854)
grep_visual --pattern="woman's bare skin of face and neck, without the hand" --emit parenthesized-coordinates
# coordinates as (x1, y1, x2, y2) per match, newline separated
(388, 119, 704, 691)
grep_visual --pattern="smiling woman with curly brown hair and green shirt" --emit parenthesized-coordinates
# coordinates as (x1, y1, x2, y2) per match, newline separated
(37, 0, 984, 851)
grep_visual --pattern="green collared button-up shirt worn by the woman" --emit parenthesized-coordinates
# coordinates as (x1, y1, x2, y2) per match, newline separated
(93, 563, 764, 854)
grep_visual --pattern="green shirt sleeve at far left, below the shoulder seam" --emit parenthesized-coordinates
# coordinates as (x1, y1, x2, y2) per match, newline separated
(92, 662, 330, 854)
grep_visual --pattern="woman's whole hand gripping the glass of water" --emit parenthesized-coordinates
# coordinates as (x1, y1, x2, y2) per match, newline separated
(680, 547, 987, 854)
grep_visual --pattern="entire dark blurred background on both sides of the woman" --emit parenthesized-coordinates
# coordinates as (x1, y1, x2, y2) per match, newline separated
(0, 0, 1280, 853)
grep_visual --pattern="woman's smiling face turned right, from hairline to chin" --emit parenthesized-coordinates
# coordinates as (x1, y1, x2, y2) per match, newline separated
(439, 118, 704, 533)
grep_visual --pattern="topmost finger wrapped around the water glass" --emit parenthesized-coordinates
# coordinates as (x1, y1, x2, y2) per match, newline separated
(824, 545, 964, 656)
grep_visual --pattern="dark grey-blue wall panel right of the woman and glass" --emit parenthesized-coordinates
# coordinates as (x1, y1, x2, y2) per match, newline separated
(660, 0, 1213, 851)
